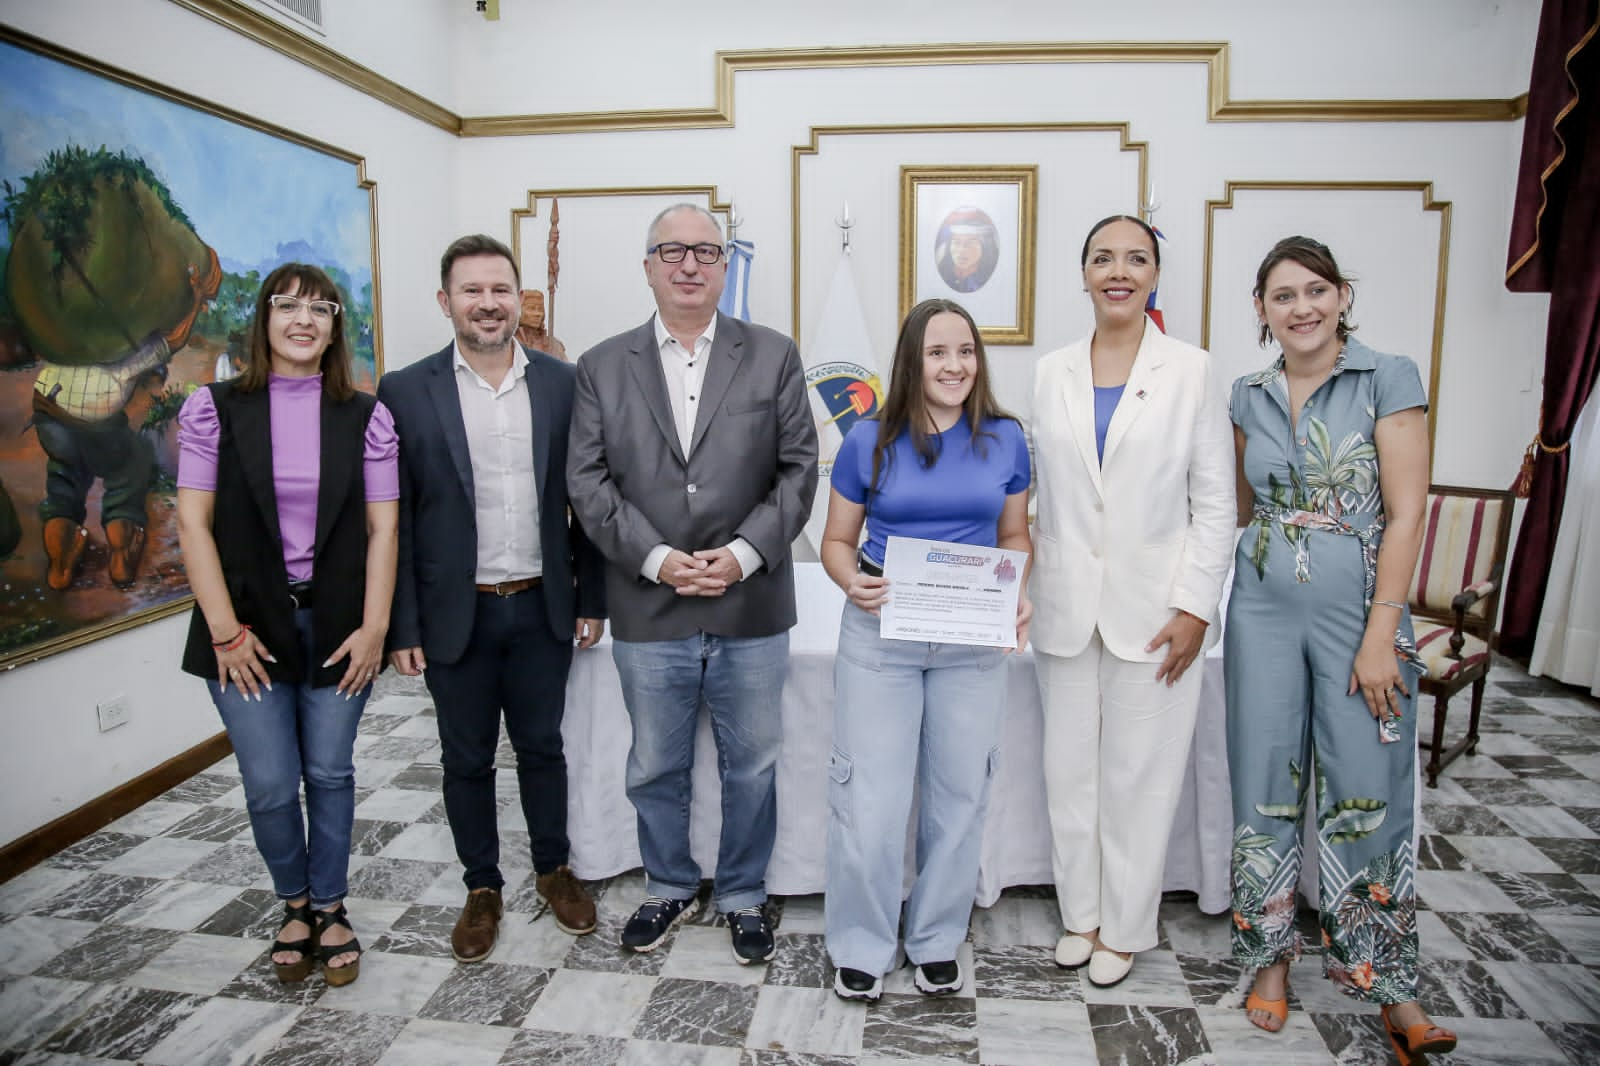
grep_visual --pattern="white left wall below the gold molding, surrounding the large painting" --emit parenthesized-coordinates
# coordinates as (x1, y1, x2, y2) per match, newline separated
(0, 0, 458, 844)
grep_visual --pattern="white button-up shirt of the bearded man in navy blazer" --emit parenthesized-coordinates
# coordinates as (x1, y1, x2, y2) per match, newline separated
(453, 341, 544, 584)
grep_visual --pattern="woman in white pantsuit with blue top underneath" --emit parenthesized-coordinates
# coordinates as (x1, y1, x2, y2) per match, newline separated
(1030, 214, 1235, 986)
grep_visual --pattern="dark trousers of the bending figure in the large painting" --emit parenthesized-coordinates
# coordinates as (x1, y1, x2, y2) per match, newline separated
(34, 411, 155, 527)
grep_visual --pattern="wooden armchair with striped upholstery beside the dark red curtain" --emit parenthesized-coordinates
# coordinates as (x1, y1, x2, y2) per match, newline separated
(1408, 485, 1512, 787)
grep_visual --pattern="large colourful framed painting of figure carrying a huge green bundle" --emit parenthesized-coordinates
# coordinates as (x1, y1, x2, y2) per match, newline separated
(0, 30, 381, 666)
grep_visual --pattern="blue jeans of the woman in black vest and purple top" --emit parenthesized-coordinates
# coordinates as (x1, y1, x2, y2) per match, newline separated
(206, 610, 373, 908)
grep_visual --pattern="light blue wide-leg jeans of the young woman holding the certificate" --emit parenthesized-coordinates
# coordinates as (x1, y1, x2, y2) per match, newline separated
(826, 603, 1006, 975)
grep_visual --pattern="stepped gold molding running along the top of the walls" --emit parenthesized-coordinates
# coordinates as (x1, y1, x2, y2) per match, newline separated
(162, 0, 1528, 138)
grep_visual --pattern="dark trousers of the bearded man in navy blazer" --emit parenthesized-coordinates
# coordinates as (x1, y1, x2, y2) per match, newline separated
(426, 586, 573, 890)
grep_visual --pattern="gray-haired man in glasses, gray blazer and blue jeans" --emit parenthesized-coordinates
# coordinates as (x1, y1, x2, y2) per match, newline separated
(566, 203, 816, 964)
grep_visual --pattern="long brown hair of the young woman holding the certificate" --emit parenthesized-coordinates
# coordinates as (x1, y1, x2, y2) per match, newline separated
(867, 299, 1016, 501)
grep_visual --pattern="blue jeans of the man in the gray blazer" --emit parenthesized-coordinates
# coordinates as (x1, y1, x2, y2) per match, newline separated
(611, 632, 789, 911)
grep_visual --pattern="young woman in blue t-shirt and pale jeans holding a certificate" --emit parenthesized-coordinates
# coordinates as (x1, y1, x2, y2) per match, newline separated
(822, 299, 1032, 1000)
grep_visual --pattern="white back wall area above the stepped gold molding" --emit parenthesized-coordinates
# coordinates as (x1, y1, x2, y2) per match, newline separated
(448, 0, 1539, 115)
